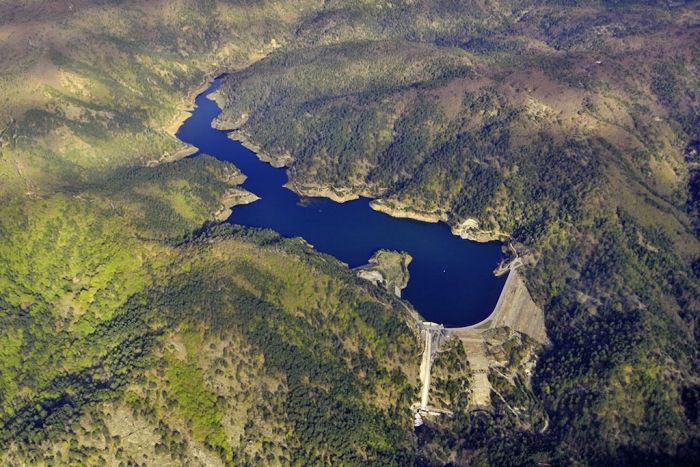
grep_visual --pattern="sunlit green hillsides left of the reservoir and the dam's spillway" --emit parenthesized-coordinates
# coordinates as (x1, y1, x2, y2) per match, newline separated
(0, 1, 418, 465)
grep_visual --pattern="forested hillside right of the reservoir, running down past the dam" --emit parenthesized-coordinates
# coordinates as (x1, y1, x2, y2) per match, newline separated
(219, 1, 700, 464)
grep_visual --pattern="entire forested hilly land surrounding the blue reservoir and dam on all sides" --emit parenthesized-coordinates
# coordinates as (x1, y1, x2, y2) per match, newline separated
(0, 0, 700, 465)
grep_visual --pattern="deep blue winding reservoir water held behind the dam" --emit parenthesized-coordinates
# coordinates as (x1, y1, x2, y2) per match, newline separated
(177, 78, 505, 327)
